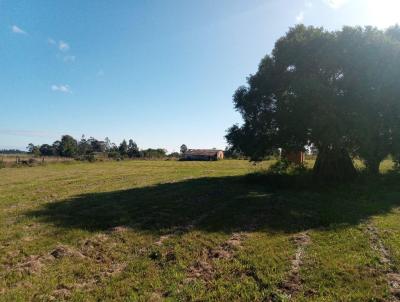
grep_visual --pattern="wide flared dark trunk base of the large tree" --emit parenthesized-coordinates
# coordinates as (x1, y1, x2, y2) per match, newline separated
(313, 146, 357, 182)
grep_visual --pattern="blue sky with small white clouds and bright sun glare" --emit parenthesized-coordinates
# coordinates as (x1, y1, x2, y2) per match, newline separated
(0, 0, 400, 152)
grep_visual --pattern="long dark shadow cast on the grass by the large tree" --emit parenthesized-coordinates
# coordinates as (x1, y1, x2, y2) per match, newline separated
(26, 173, 400, 234)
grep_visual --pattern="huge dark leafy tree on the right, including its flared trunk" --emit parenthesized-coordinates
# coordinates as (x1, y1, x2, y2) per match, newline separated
(226, 25, 400, 179)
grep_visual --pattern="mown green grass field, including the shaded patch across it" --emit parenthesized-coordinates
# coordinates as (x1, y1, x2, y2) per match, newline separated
(0, 160, 400, 301)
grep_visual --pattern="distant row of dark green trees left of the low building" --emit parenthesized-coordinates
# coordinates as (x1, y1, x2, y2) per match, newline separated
(27, 135, 167, 160)
